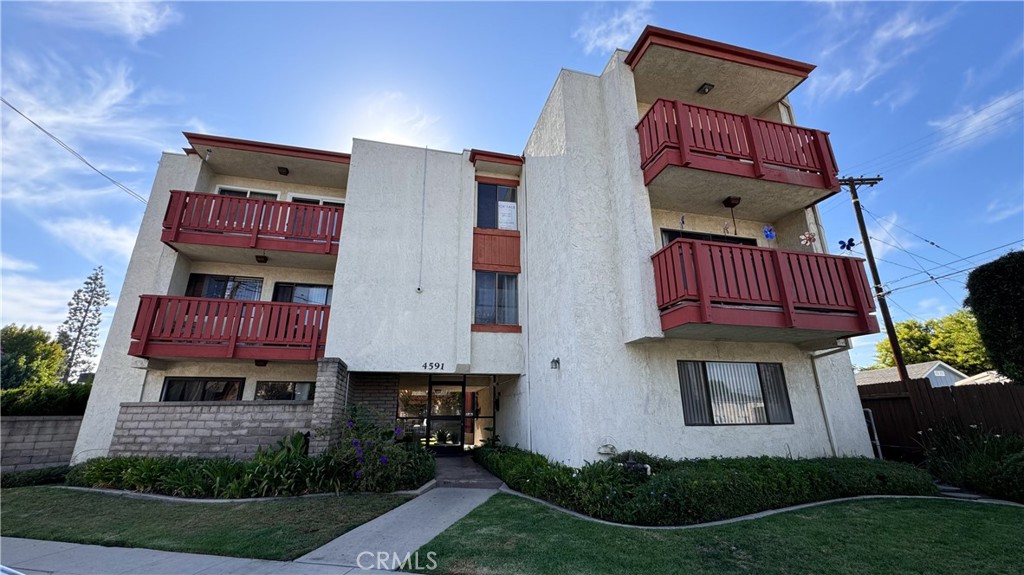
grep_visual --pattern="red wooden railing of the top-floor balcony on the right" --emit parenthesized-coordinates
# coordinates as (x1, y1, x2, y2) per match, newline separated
(637, 99, 839, 190)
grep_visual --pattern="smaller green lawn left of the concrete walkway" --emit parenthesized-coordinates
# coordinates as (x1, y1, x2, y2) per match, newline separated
(0, 487, 408, 560)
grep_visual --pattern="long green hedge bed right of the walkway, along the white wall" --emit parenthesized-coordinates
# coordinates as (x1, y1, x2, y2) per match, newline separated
(474, 447, 936, 525)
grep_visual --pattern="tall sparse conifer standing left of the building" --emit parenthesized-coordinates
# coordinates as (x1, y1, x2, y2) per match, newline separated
(57, 266, 111, 384)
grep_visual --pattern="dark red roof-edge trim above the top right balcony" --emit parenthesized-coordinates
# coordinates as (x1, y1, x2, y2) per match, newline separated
(626, 26, 816, 78)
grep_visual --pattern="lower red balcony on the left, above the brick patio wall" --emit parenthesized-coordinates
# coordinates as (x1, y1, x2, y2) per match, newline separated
(128, 296, 331, 361)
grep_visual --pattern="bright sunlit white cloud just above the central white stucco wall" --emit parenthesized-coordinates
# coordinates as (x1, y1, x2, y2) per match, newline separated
(336, 91, 452, 149)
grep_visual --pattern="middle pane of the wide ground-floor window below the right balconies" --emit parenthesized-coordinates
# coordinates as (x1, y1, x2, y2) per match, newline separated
(708, 361, 768, 425)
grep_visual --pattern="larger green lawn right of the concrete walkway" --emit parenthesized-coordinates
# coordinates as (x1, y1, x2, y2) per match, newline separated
(411, 494, 1024, 575)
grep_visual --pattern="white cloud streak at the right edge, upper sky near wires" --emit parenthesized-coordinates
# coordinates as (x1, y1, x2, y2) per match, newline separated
(928, 91, 1024, 152)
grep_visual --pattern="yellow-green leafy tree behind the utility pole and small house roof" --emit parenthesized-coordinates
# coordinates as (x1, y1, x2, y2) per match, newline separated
(874, 309, 992, 375)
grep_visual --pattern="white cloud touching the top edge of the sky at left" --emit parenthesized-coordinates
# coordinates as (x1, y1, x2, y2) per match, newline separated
(34, 0, 181, 43)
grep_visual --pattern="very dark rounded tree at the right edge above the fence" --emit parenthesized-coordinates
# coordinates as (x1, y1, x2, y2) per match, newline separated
(965, 252, 1024, 385)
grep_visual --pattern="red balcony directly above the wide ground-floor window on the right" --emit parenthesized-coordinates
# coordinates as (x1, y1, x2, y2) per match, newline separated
(651, 239, 879, 344)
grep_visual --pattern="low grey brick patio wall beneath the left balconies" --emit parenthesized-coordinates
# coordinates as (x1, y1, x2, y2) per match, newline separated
(110, 399, 318, 458)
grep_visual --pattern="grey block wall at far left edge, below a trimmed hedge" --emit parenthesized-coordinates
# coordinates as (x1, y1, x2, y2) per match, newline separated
(0, 415, 82, 472)
